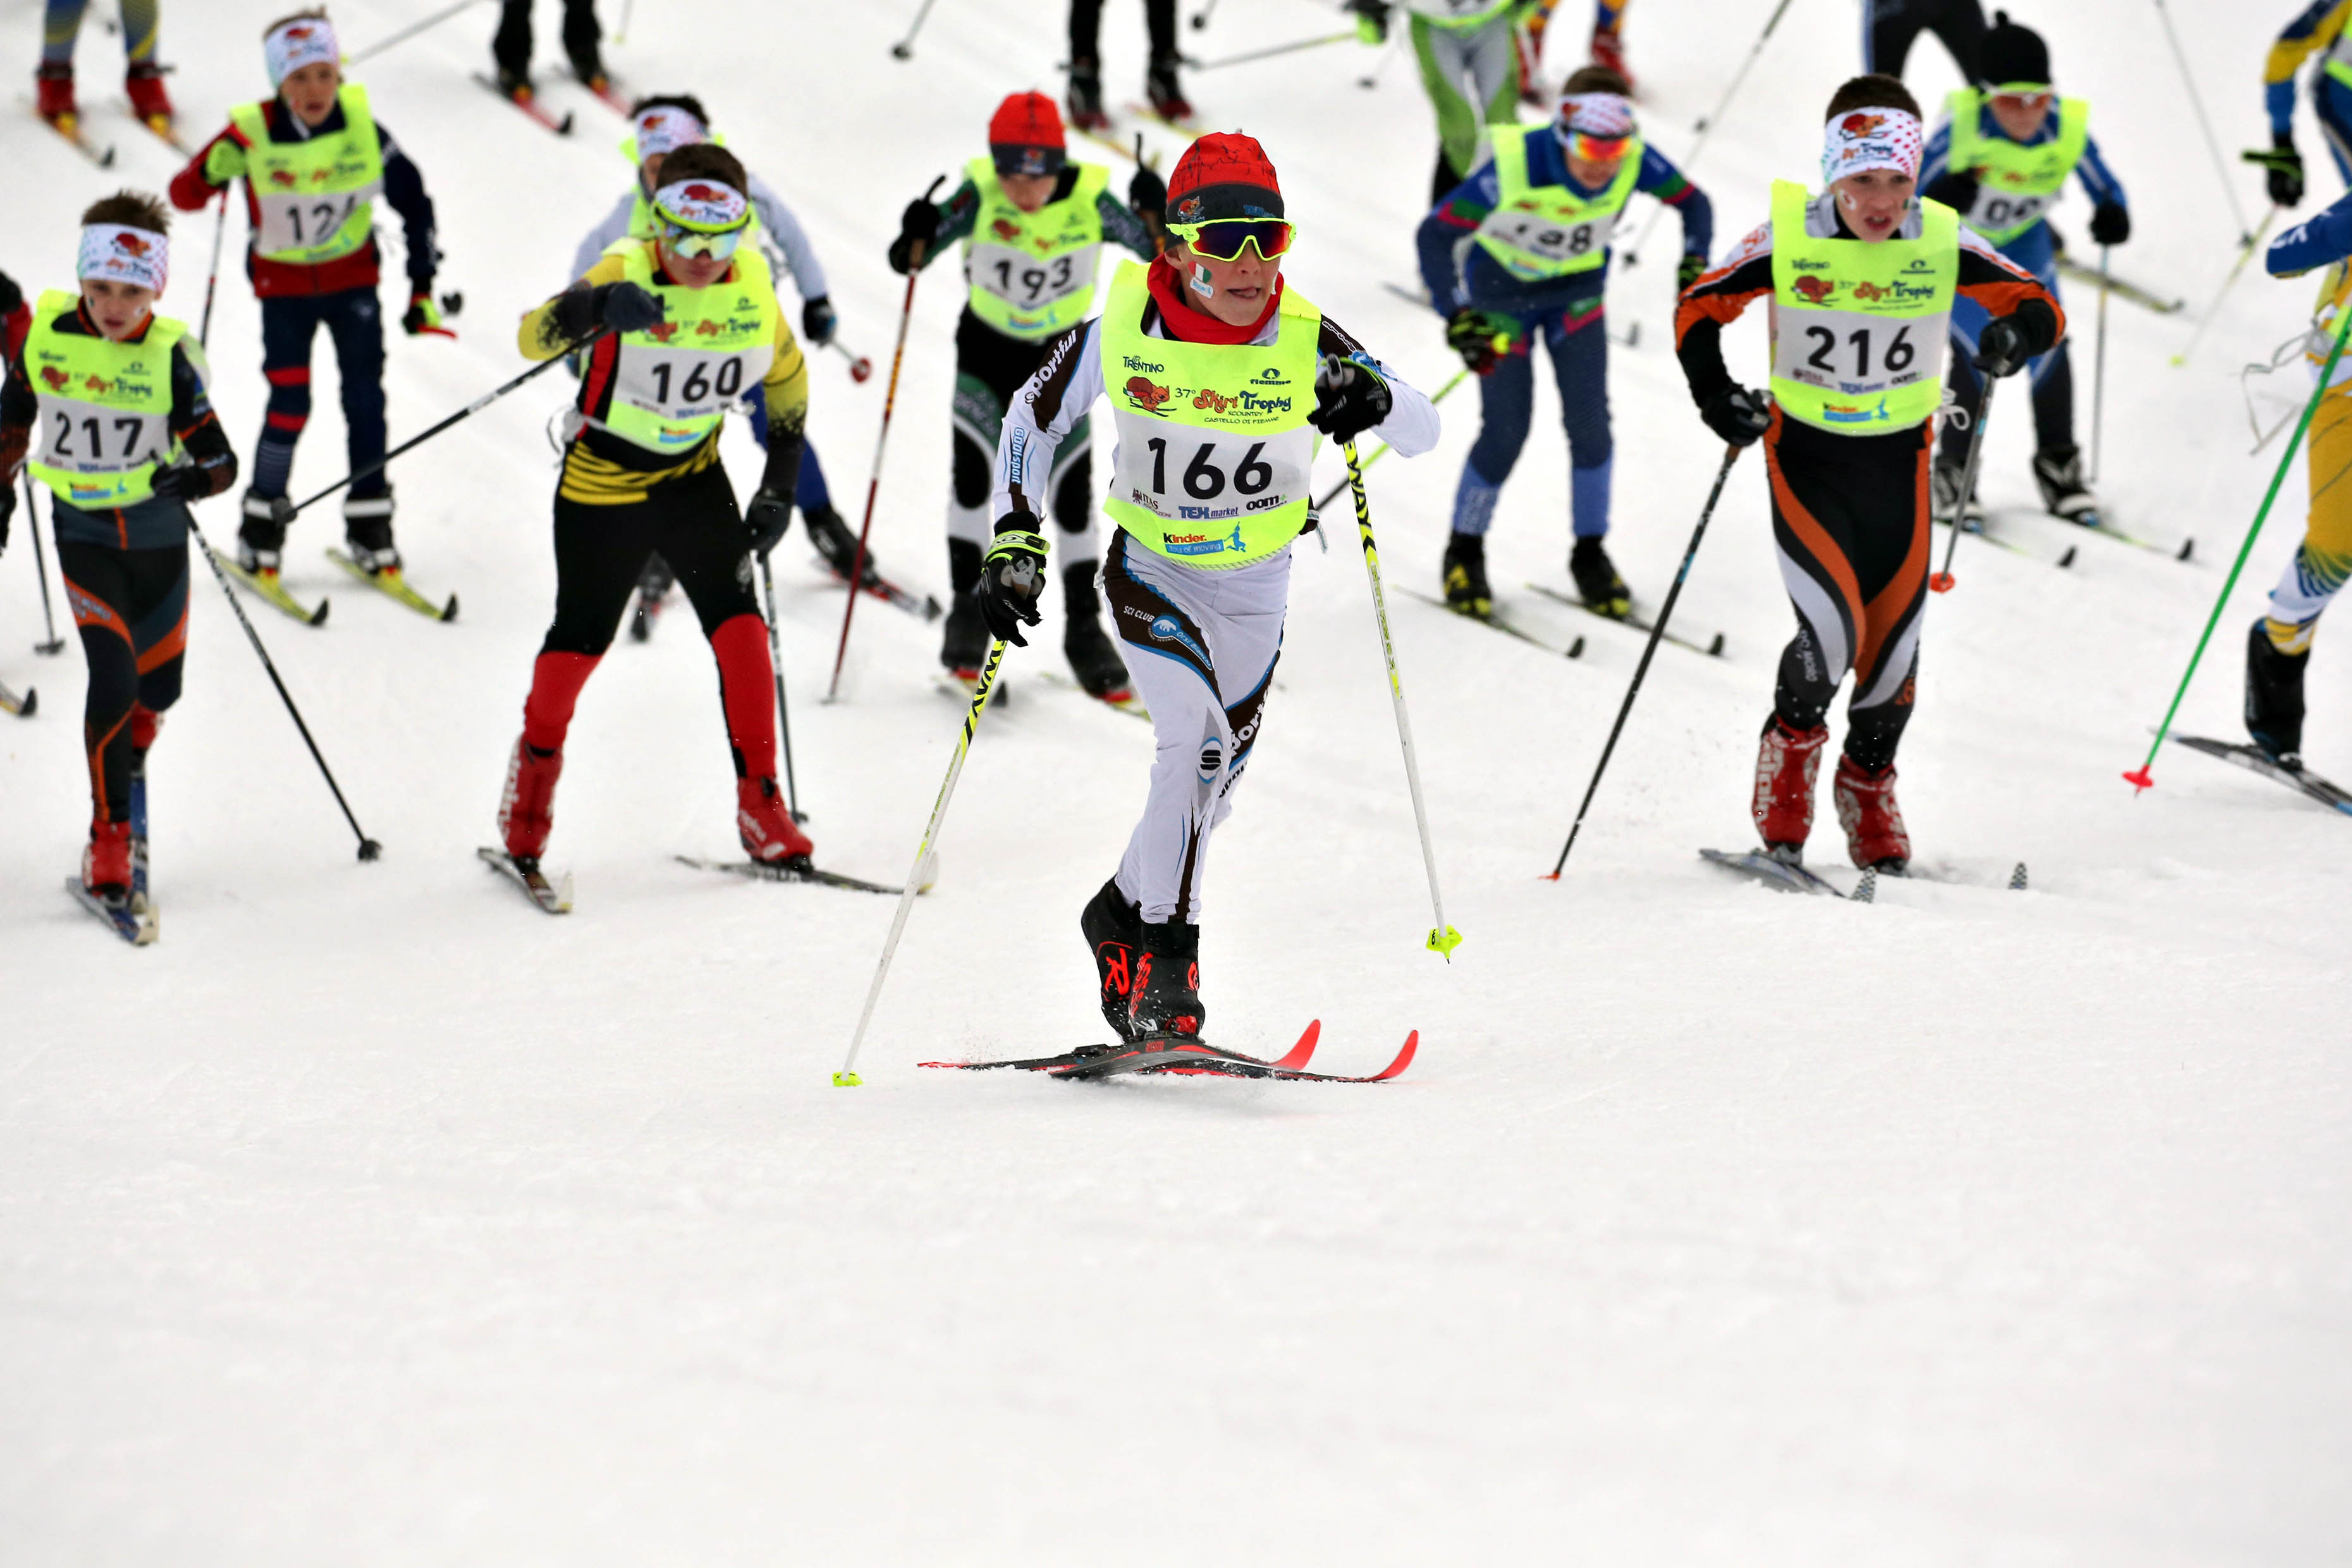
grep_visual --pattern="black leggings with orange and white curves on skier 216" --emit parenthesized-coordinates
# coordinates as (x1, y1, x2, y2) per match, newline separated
(1764, 413, 1931, 769)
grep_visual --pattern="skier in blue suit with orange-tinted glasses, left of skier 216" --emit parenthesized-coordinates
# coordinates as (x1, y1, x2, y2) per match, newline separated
(1421, 66, 1715, 618)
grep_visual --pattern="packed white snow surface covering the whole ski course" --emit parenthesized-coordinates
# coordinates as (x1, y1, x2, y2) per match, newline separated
(0, 0, 2352, 1565)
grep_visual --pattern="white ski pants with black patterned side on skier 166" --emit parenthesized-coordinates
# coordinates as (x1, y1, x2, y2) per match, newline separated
(1103, 529, 1291, 924)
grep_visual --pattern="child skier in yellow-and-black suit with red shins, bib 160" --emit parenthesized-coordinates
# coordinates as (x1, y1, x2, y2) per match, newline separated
(499, 141, 809, 870)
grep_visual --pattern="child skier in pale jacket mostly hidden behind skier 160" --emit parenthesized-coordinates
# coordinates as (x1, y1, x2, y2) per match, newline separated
(572, 94, 879, 639)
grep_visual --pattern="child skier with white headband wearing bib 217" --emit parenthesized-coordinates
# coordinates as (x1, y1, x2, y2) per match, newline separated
(0, 190, 238, 907)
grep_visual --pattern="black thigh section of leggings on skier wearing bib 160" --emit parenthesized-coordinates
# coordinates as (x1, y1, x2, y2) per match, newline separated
(539, 463, 760, 656)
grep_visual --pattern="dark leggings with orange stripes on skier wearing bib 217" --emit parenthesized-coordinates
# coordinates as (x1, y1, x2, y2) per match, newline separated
(56, 538, 188, 823)
